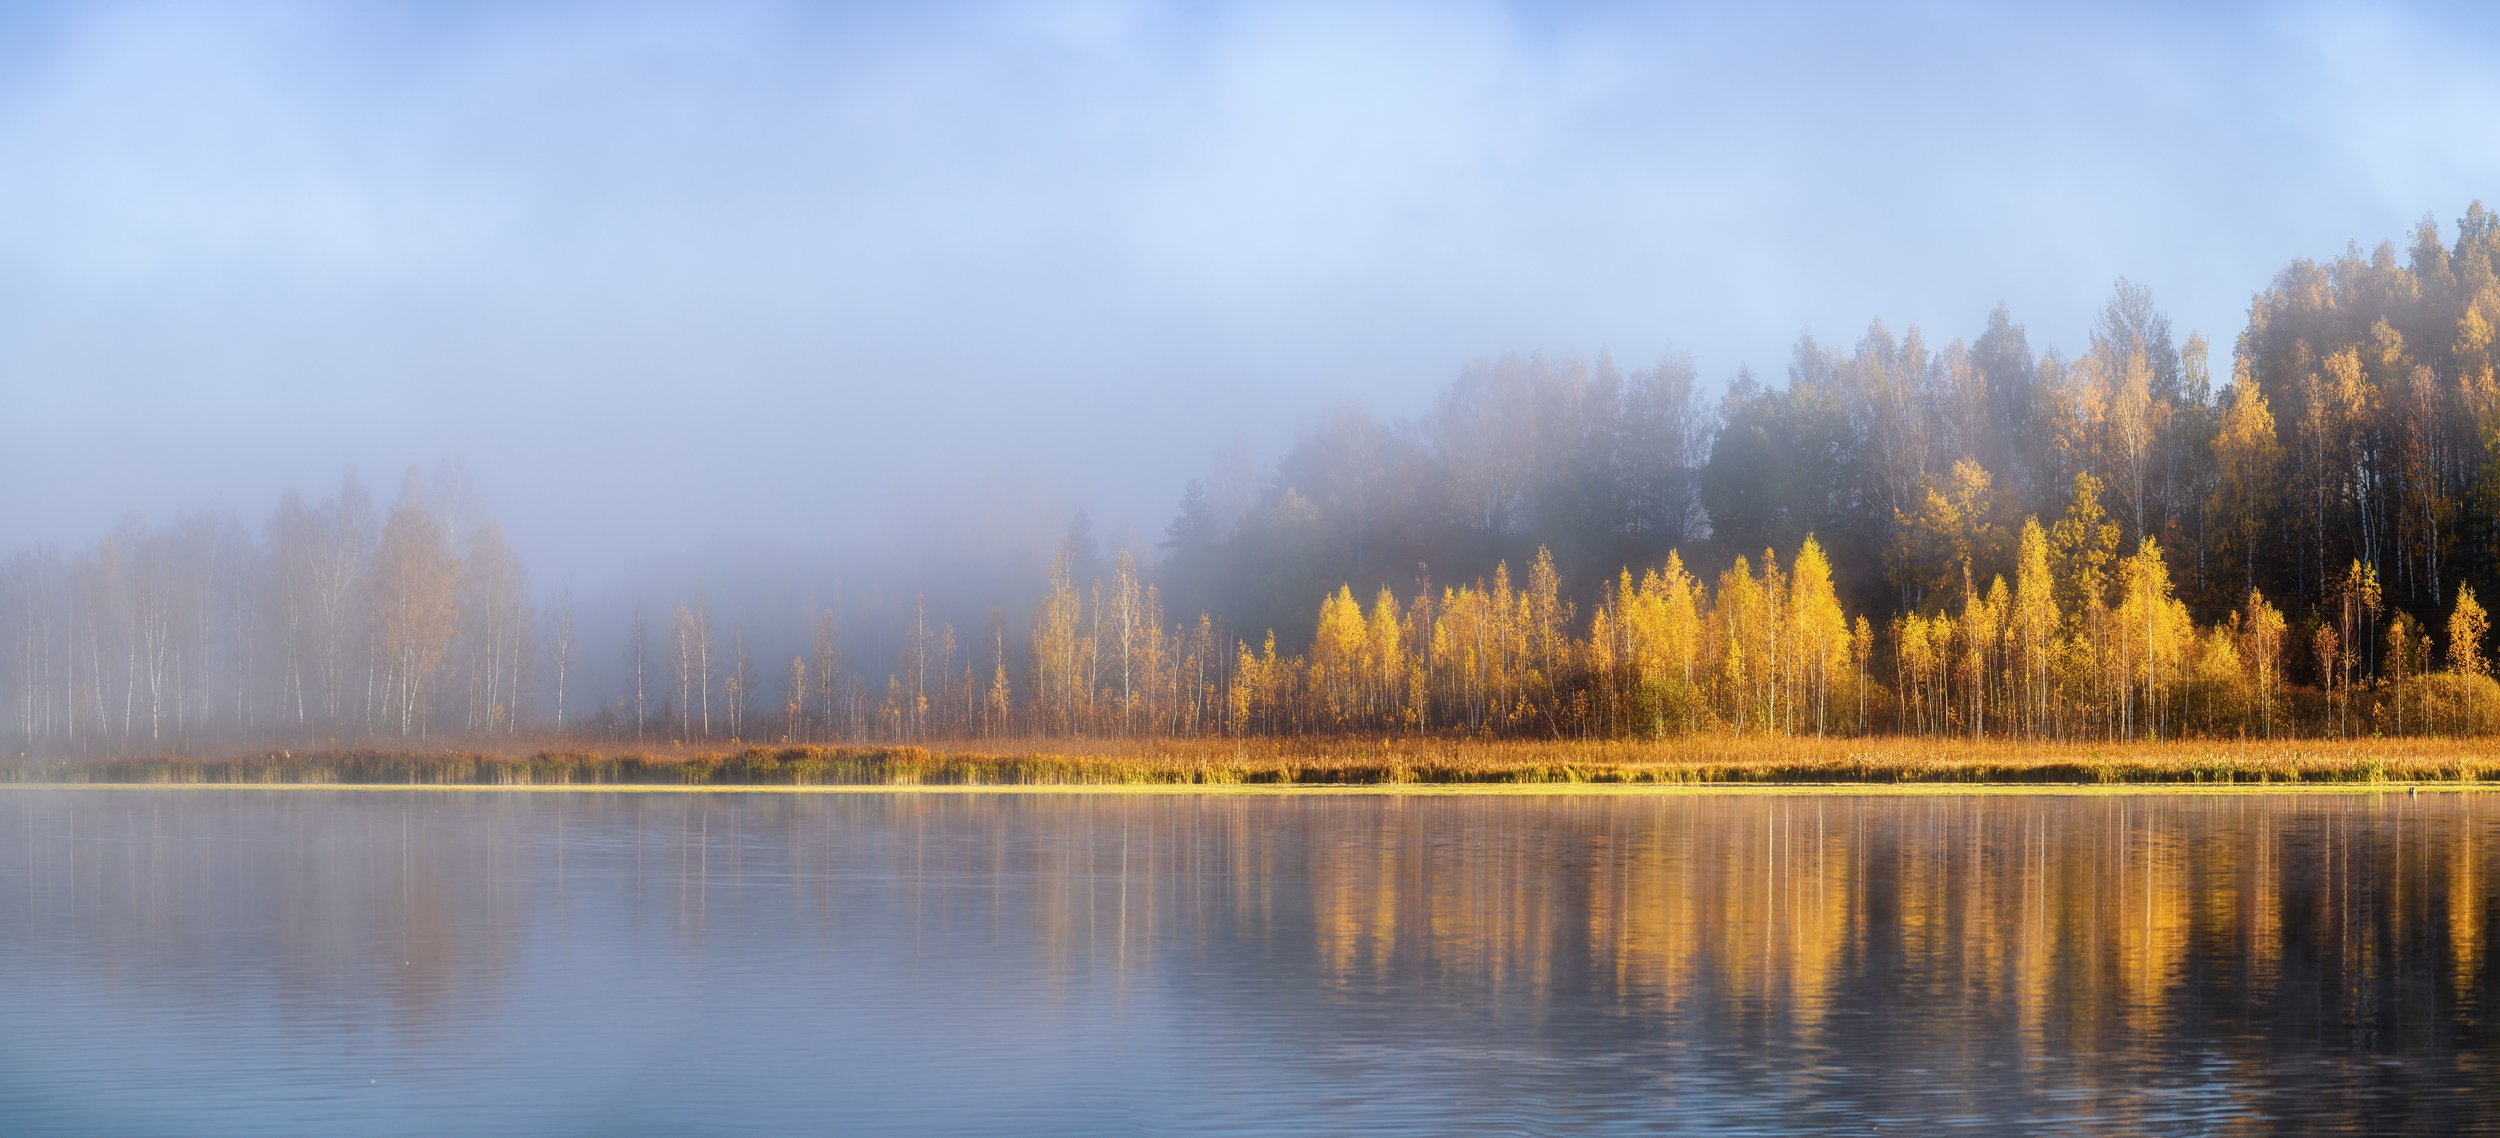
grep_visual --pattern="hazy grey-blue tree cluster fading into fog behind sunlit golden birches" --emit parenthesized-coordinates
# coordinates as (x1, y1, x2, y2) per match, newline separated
(1160, 355, 1713, 637)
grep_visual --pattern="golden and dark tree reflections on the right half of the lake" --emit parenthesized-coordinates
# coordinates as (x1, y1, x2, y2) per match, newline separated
(1243, 795, 2493, 1115)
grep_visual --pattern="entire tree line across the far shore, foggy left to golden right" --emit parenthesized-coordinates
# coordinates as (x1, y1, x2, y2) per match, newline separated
(14, 203, 2500, 753)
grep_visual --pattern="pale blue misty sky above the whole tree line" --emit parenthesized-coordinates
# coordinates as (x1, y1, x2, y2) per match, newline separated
(0, 3, 2500, 583)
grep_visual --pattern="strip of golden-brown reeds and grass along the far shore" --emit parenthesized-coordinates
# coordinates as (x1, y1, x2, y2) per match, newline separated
(14, 735, 2500, 788)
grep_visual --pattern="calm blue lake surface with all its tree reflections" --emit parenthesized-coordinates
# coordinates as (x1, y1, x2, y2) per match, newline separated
(0, 790, 2500, 1135)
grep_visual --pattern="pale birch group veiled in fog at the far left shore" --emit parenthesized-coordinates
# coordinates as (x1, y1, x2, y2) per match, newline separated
(0, 475, 542, 753)
